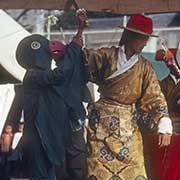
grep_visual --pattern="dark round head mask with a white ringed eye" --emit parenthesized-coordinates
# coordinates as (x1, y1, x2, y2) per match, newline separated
(16, 34, 52, 69)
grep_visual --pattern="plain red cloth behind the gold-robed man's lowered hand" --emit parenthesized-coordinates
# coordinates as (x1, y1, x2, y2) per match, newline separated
(148, 134, 180, 180)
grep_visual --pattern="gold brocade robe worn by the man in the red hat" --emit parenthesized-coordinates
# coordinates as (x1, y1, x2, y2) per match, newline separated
(87, 47, 167, 180)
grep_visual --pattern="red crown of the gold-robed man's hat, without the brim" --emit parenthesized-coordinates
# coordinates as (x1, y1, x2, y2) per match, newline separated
(127, 15, 153, 34)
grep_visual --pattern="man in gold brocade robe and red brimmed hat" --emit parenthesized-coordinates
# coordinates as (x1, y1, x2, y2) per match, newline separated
(83, 15, 172, 180)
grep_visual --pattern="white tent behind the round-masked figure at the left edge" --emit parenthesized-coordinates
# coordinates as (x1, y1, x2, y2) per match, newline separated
(0, 10, 30, 134)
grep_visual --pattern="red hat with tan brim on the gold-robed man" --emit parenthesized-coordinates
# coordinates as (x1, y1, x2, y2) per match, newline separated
(120, 15, 158, 37)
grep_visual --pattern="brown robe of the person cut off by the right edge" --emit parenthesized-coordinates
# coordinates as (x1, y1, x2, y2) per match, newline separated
(160, 75, 180, 133)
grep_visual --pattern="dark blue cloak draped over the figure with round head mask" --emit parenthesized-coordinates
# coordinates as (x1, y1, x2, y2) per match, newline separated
(23, 42, 86, 164)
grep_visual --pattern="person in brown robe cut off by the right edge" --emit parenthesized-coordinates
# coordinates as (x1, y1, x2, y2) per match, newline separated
(156, 48, 180, 133)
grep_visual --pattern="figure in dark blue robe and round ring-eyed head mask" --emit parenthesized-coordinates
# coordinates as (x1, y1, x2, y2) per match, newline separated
(13, 12, 86, 180)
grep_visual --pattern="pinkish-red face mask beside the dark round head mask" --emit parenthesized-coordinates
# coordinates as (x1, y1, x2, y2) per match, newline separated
(49, 41, 67, 59)
